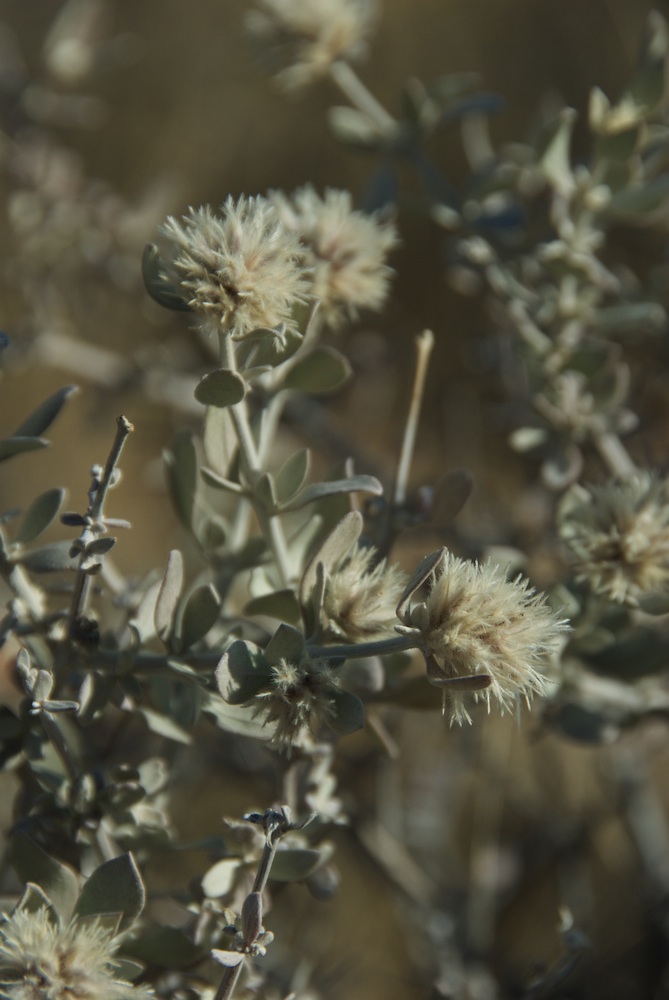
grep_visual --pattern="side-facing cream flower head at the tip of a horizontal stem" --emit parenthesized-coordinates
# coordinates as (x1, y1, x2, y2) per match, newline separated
(398, 553, 568, 724)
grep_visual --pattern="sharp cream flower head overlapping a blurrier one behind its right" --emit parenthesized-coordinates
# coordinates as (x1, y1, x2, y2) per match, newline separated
(163, 197, 308, 340)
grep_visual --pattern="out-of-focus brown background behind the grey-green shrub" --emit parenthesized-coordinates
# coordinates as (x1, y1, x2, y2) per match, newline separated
(0, 0, 669, 1000)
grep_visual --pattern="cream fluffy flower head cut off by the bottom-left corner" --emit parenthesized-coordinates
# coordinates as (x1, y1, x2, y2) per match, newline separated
(0, 907, 153, 1000)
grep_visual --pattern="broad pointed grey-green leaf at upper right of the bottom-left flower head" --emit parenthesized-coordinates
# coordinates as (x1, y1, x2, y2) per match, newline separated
(74, 854, 146, 930)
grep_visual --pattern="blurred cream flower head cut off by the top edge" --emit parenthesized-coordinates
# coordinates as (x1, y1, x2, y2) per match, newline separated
(246, 0, 376, 89)
